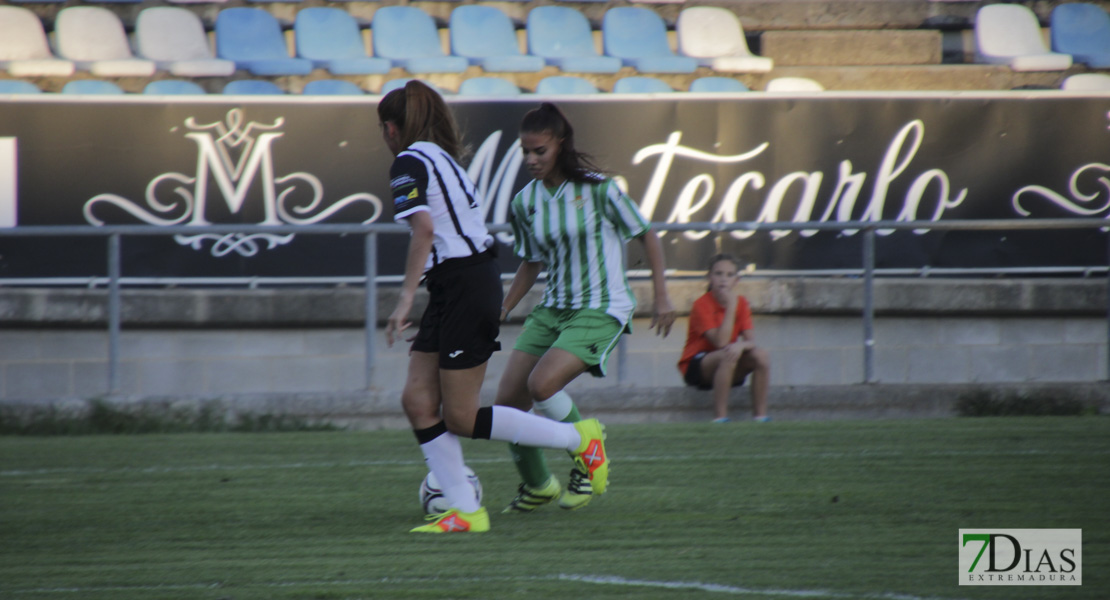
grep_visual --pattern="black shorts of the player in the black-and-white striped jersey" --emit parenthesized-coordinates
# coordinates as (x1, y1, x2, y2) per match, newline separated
(412, 253, 503, 369)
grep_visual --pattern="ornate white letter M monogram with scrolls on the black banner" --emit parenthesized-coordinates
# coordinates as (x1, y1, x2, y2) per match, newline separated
(84, 109, 382, 256)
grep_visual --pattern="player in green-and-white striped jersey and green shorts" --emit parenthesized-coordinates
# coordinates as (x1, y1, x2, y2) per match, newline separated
(496, 102, 675, 512)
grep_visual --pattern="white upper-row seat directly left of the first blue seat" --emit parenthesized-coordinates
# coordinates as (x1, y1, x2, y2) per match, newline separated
(135, 7, 235, 77)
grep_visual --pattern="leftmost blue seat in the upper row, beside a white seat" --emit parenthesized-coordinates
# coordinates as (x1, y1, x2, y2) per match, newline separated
(215, 7, 312, 77)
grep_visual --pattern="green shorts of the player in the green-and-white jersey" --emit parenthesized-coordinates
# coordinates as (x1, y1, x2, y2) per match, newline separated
(513, 306, 625, 377)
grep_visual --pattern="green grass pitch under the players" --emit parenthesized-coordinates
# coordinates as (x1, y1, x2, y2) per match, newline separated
(0, 417, 1110, 600)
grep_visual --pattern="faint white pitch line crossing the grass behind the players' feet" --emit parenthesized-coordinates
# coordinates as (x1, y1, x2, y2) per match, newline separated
(0, 449, 1110, 477)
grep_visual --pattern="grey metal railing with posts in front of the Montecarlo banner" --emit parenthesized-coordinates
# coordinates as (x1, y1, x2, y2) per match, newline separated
(0, 217, 1110, 395)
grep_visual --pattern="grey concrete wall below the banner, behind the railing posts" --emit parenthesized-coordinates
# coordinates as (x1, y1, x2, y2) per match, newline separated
(0, 279, 1108, 400)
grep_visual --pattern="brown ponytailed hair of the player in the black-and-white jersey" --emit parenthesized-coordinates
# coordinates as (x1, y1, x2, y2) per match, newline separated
(377, 79, 465, 161)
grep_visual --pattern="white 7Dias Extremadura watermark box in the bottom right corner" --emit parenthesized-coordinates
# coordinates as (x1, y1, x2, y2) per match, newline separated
(960, 529, 1083, 586)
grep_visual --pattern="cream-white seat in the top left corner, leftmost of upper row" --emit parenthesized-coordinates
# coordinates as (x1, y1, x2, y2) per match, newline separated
(0, 7, 74, 77)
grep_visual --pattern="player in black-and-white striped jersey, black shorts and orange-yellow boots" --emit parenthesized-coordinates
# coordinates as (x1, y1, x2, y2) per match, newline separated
(377, 81, 608, 533)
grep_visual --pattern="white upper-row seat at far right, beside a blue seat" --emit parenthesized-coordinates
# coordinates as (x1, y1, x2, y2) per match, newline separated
(975, 4, 1071, 71)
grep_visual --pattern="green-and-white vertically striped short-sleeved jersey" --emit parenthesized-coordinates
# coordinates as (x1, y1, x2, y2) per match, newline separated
(509, 179, 649, 325)
